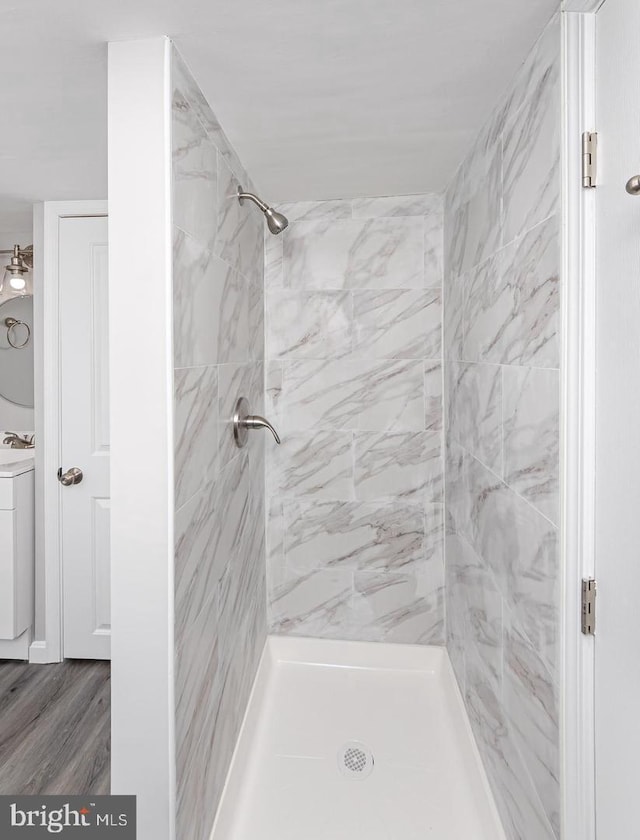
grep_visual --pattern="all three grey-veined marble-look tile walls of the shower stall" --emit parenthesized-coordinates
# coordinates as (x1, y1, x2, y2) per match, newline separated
(164, 8, 560, 840)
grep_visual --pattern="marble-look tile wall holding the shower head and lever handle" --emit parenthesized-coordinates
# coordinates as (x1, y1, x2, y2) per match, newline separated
(172, 52, 267, 840)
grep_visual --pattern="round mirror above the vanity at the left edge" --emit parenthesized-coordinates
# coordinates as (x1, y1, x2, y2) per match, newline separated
(0, 295, 33, 408)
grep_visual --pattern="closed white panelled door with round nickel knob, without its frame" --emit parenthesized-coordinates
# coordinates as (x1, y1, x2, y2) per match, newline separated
(59, 216, 111, 659)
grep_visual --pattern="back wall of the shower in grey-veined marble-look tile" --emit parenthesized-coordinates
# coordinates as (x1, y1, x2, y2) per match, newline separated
(265, 195, 444, 644)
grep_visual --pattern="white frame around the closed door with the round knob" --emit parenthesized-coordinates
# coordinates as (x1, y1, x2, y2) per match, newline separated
(29, 199, 107, 663)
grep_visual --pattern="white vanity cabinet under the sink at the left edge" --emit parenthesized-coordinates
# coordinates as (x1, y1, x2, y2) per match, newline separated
(0, 451, 35, 640)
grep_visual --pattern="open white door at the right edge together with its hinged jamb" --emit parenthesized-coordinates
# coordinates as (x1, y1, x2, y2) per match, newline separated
(562, 0, 640, 840)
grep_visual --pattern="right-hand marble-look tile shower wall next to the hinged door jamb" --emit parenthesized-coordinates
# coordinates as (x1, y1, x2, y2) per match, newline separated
(443, 17, 561, 840)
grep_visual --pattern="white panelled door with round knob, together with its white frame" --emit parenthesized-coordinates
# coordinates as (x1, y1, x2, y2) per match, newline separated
(35, 201, 110, 663)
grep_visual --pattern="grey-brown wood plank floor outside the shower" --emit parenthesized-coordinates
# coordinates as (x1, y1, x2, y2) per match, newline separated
(0, 660, 111, 794)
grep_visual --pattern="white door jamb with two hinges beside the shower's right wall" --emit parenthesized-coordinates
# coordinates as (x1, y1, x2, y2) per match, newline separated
(560, 8, 602, 840)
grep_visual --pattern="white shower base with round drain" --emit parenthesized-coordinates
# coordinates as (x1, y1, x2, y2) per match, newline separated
(211, 637, 504, 840)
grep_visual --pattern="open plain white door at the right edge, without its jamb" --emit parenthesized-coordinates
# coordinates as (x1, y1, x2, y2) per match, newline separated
(595, 0, 640, 840)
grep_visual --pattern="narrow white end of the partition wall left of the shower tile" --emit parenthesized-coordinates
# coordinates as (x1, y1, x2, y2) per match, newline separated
(108, 38, 175, 840)
